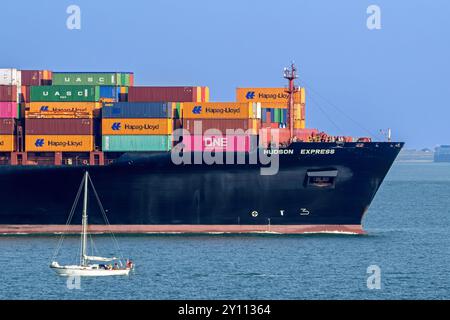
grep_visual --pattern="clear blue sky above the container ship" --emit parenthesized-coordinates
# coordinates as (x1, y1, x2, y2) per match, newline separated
(0, 0, 450, 148)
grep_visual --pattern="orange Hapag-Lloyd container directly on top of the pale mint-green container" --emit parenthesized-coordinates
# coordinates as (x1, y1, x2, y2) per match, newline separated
(102, 118, 173, 135)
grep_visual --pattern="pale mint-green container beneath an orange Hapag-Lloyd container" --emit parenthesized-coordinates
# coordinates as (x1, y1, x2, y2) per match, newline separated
(102, 135, 172, 152)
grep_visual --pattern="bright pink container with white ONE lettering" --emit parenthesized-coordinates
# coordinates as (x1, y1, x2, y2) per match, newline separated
(182, 135, 258, 152)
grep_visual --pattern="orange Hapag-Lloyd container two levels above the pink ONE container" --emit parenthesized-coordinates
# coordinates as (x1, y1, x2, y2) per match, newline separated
(183, 102, 261, 119)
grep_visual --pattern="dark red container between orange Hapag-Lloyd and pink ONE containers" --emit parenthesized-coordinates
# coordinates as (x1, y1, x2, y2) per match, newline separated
(183, 119, 260, 135)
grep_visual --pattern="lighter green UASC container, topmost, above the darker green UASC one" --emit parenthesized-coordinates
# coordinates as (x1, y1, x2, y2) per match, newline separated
(52, 72, 130, 86)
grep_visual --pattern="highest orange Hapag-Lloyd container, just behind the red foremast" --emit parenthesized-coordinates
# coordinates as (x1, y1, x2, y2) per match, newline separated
(236, 88, 300, 104)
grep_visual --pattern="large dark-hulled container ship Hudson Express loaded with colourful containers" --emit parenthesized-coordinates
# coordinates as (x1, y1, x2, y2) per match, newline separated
(0, 65, 403, 234)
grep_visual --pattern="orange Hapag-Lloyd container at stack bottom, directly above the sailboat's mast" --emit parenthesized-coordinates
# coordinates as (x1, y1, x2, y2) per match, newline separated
(25, 135, 94, 152)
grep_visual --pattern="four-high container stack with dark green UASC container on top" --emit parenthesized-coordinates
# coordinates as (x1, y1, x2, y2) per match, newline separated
(25, 85, 100, 152)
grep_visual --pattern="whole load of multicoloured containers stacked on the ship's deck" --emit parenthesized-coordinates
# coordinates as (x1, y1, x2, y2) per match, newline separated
(0, 69, 315, 157)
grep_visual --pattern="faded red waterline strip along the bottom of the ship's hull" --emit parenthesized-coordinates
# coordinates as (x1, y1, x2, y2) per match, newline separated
(0, 224, 365, 234)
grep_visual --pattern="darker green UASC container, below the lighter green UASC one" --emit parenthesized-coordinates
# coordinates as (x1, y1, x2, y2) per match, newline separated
(30, 86, 100, 102)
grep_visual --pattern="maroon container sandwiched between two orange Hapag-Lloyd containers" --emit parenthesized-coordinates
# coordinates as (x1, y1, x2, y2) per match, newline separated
(25, 118, 94, 135)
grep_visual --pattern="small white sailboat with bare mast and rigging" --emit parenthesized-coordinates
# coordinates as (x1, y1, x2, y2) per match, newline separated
(50, 171, 134, 276)
